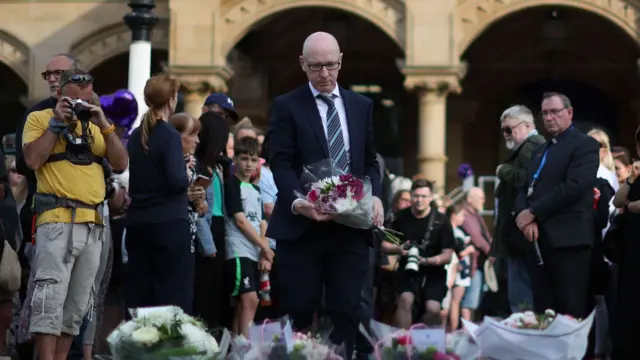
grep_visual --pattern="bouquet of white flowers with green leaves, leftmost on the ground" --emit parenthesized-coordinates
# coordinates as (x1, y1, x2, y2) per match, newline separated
(107, 306, 230, 360)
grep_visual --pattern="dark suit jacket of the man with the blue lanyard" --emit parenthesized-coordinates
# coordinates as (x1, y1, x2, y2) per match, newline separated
(516, 126, 600, 249)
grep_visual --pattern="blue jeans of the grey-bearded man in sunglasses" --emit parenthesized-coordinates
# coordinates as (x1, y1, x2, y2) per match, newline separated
(507, 257, 533, 312)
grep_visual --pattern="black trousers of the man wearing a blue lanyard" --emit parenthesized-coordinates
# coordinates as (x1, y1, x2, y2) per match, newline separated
(529, 246, 593, 319)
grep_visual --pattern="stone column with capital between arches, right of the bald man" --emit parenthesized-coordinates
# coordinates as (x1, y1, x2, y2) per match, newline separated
(403, 67, 461, 188)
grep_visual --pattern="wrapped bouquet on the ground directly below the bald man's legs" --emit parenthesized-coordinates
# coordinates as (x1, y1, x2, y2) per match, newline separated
(229, 318, 343, 360)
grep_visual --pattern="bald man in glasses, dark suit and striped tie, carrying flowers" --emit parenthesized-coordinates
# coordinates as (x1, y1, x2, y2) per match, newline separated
(267, 32, 384, 359)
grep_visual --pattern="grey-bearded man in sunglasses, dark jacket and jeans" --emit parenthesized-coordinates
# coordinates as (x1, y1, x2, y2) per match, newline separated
(490, 105, 545, 312)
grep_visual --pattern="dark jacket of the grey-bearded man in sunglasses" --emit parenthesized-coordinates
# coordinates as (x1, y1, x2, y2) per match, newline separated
(490, 135, 546, 257)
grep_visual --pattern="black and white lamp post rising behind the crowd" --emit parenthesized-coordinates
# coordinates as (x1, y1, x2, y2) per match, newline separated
(124, 0, 158, 128)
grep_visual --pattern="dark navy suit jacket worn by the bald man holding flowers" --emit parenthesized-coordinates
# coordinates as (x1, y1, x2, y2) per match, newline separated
(267, 84, 381, 240)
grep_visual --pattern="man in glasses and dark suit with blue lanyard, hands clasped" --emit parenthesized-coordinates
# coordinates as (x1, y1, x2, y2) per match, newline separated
(515, 93, 600, 319)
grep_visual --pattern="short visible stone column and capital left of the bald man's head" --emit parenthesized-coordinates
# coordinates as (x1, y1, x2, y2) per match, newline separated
(167, 66, 233, 117)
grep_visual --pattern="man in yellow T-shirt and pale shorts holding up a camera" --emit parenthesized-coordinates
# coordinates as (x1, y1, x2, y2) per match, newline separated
(23, 69, 128, 360)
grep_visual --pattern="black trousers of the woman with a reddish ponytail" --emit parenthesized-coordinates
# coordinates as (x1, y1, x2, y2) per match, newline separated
(125, 219, 194, 314)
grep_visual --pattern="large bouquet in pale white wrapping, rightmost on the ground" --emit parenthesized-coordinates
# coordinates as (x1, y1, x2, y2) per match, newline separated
(462, 310, 594, 360)
